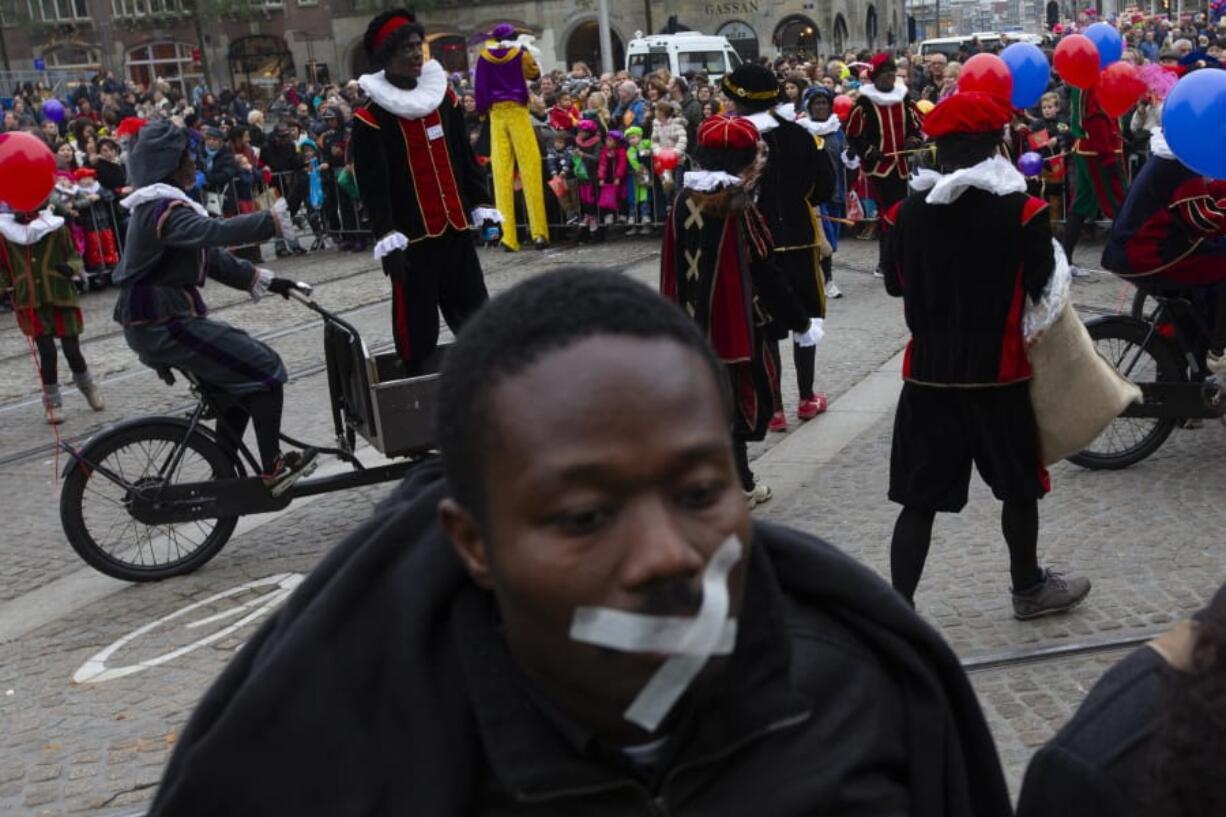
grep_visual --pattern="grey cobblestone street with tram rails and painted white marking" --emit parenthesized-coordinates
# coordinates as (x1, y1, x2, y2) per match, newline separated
(0, 231, 1226, 817)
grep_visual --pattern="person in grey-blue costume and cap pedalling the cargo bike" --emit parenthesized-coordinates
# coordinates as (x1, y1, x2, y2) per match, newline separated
(113, 120, 316, 494)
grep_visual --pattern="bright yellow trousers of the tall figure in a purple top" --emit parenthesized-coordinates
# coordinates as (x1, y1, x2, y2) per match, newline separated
(489, 102, 549, 250)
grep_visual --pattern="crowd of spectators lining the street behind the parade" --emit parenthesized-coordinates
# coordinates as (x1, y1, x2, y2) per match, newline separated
(2, 5, 1226, 281)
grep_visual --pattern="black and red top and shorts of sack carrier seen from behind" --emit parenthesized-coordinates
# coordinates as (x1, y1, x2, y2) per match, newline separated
(881, 188, 1054, 513)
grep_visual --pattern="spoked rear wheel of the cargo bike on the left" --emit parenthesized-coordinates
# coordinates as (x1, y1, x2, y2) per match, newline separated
(60, 420, 238, 581)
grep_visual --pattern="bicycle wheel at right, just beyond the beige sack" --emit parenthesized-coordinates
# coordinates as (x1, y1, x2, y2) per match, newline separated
(1069, 318, 1184, 470)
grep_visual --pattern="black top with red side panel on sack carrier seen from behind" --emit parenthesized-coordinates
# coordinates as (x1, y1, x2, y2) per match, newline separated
(881, 188, 1054, 385)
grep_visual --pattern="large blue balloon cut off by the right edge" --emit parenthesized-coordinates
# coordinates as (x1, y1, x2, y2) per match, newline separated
(1162, 70, 1226, 179)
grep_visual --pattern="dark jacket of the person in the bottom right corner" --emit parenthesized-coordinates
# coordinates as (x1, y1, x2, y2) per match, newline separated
(1018, 646, 1173, 817)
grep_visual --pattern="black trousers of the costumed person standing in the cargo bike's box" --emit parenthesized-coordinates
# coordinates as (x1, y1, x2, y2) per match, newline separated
(391, 229, 489, 375)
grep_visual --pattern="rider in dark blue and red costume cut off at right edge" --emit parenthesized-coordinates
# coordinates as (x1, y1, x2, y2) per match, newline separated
(1102, 130, 1226, 374)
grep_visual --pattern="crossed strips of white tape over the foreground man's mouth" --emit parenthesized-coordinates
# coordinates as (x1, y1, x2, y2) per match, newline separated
(570, 536, 743, 732)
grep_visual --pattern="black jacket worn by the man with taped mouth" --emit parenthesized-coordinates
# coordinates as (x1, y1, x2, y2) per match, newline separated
(150, 462, 1010, 817)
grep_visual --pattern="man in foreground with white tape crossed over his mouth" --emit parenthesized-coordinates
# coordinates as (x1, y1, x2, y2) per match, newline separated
(150, 270, 1010, 817)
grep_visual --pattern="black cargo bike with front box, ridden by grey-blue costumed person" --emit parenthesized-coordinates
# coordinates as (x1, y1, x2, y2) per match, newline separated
(60, 285, 447, 581)
